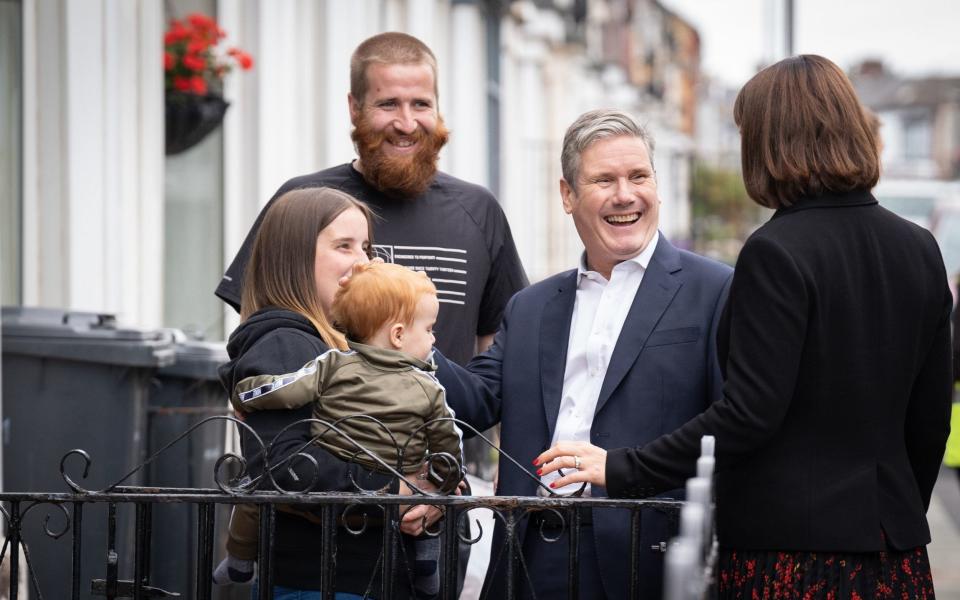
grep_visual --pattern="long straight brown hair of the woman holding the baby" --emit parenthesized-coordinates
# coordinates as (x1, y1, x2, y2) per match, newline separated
(240, 187, 373, 350)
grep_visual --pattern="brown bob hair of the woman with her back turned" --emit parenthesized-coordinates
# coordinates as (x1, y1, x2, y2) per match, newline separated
(733, 54, 880, 208)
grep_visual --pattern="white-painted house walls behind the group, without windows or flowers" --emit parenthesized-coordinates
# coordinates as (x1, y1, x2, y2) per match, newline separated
(16, 0, 689, 331)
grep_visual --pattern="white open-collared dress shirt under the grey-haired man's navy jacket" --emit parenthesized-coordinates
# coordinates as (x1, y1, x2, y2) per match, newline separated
(541, 232, 660, 495)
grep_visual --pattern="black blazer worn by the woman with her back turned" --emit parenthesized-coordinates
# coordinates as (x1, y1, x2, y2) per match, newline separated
(607, 191, 952, 552)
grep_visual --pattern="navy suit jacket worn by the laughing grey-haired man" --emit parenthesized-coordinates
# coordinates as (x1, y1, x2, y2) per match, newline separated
(437, 234, 733, 598)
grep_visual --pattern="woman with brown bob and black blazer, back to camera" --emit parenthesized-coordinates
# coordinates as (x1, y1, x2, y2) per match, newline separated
(538, 55, 952, 598)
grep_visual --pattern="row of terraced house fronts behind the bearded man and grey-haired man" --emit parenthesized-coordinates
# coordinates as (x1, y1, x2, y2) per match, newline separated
(0, 0, 699, 339)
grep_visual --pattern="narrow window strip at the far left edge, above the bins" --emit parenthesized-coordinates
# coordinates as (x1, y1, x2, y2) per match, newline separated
(0, 0, 23, 305)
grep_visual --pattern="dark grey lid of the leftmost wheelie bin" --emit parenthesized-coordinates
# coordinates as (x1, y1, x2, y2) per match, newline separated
(0, 306, 176, 367)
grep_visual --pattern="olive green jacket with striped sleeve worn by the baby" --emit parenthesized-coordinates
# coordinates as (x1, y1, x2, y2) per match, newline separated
(230, 342, 463, 481)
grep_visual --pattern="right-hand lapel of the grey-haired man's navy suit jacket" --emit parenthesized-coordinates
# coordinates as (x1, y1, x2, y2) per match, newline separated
(594, 234, 682, 414)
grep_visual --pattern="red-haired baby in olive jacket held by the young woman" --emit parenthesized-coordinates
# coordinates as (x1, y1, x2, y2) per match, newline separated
(214, 263, 463, 597)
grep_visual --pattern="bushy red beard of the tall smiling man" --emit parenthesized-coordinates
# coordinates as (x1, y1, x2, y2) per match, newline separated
(350, 113, 450, 198)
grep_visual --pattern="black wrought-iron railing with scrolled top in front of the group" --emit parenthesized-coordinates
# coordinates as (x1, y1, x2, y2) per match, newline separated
(0, 416, 712, 600)
